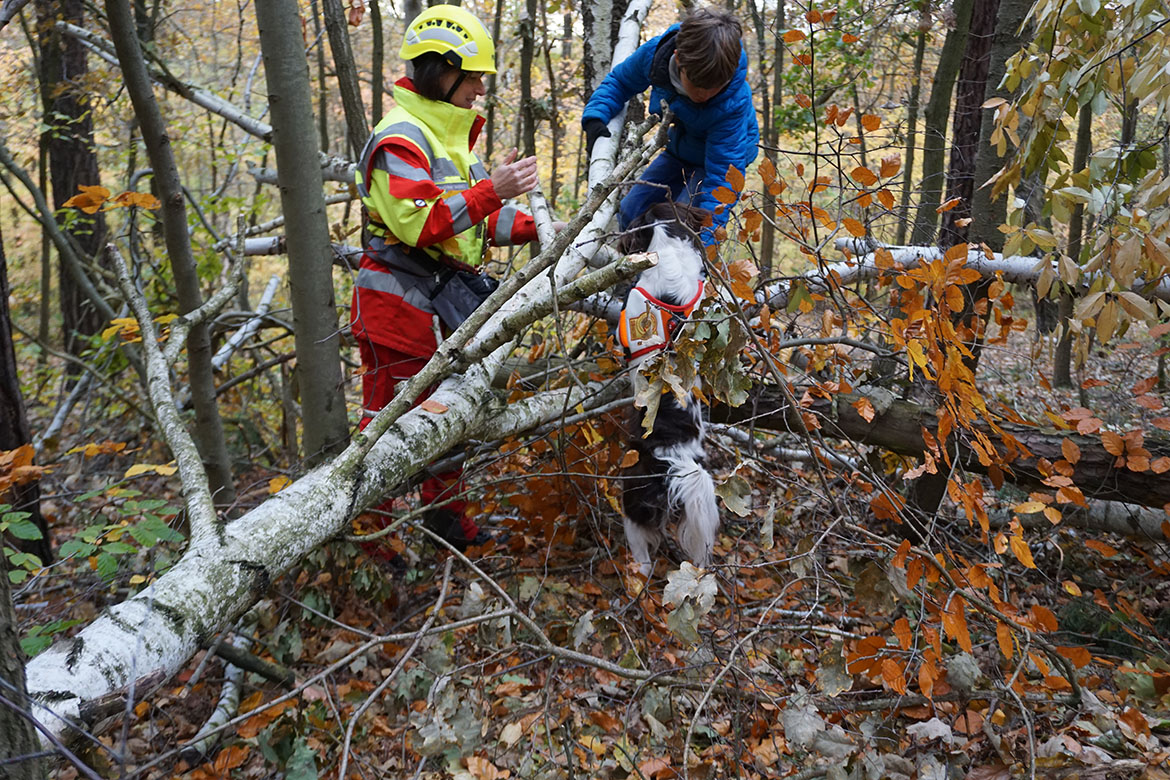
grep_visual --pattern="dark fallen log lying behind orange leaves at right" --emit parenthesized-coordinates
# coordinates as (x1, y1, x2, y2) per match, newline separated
(711, 387, 1170, 508)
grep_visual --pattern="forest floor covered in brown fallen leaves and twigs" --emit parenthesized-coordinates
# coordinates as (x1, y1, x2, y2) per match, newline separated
(16, 294, 1170, 780)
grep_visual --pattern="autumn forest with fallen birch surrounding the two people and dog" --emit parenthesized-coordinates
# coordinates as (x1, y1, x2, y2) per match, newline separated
(0, 0, 1170, 779)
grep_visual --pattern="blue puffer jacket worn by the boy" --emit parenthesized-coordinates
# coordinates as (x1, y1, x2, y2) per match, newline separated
(581, 25, 759, 243)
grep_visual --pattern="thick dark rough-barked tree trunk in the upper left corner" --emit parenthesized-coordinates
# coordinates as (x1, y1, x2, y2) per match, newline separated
(36, 0, 105, 362)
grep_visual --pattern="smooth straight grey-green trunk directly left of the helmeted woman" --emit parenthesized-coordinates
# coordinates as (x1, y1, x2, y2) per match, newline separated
(256, 0, 346, 462)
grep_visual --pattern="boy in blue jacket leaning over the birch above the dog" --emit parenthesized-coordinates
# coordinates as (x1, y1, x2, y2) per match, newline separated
(581, 8, 759, 247)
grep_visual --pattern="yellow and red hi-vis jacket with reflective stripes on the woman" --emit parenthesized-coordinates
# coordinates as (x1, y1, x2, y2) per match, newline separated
(351, 78, 536, 357)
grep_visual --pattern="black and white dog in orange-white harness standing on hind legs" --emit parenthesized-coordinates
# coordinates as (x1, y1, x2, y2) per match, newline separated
(619, 203, 720, 574)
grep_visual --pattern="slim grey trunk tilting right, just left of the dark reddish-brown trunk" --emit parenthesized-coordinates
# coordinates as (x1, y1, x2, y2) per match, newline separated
(910, 0, 975, 246)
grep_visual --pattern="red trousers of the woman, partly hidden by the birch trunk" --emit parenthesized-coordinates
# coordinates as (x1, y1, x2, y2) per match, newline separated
(358, 339, 480, 552)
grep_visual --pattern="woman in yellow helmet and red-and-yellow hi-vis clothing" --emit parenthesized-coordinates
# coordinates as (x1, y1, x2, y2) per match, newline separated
(351, 5, 537, 561)
